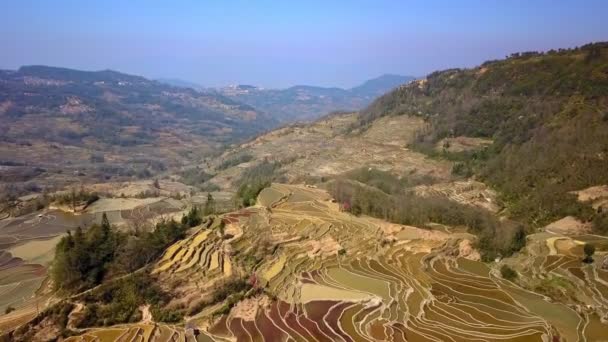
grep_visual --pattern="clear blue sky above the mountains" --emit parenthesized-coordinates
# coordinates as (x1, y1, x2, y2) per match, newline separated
(0, 0, 608, 88)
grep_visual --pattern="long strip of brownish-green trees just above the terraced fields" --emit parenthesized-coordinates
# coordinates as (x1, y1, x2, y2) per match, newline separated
(328, 171, 526, 260)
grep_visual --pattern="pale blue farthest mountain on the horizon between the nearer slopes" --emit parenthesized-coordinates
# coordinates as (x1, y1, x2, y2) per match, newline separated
(218, 75, 414, 122)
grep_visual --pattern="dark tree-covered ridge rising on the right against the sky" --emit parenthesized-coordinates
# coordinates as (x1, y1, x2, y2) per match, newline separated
(355, 43, 608, 233)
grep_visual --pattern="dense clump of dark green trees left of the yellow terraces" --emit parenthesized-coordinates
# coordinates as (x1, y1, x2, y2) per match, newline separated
(51, 214, 190, 292)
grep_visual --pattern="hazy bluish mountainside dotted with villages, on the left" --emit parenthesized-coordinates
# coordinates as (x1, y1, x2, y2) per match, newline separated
(0, 66, 276, 195)
